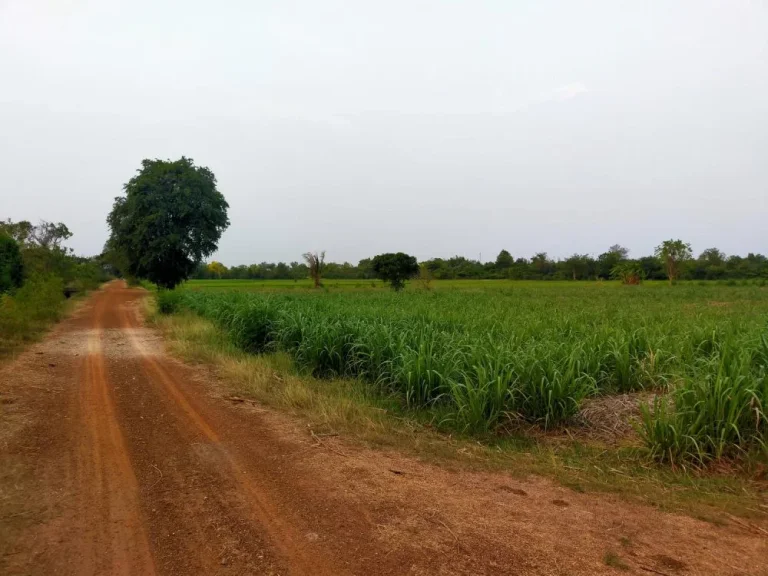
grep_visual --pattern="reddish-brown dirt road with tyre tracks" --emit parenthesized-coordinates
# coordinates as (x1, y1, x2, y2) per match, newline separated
(0, 282, 768, 576)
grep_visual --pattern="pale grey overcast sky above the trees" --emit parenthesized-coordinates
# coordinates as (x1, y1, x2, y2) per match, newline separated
(0, 0, 768, 265)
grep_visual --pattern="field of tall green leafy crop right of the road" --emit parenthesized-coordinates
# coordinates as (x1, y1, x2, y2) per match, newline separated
(160, 280, 768, 464)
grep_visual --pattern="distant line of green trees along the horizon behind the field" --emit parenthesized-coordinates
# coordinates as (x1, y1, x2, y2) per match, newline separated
(191, 240, 768, 283)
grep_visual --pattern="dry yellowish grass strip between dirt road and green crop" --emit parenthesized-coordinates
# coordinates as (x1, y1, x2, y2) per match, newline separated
(144, 298, 767, 524)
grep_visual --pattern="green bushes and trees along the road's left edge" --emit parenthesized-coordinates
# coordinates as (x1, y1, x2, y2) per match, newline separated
(0, 220, 109, 357)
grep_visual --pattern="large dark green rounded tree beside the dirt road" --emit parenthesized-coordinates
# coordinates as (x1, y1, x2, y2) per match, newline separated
(107, 156, 229, 288)
